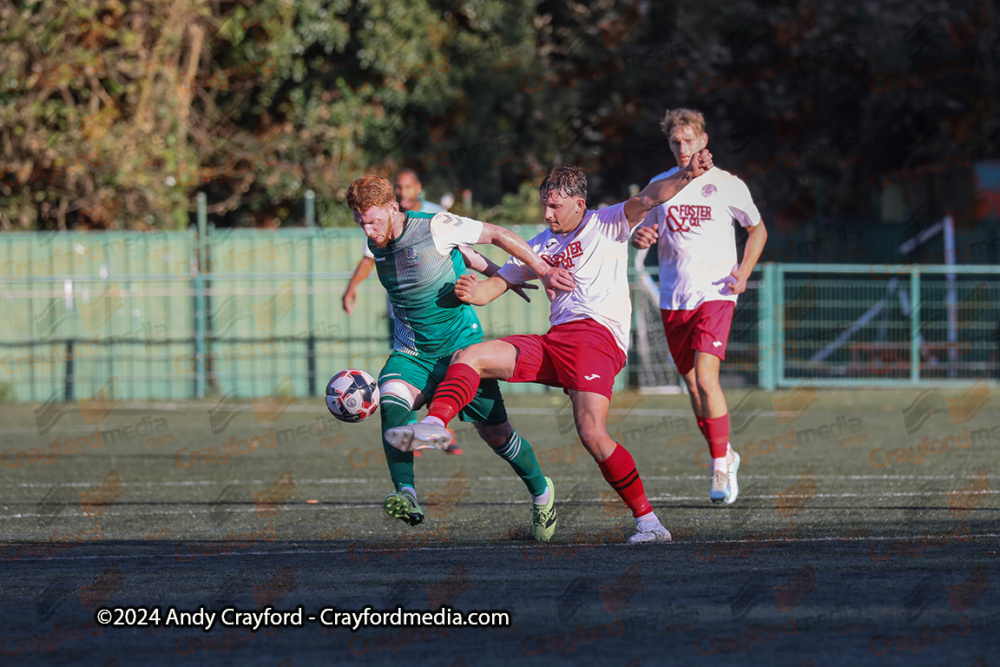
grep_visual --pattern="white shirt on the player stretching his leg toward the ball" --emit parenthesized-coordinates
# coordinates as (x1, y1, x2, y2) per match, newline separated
(499, 202, 632, 353)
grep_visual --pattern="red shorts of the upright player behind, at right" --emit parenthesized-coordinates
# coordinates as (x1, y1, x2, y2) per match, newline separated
(660, 301, 736, 375)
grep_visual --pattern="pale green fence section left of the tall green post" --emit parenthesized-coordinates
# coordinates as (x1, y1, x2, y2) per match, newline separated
(0, 232, 194, 401)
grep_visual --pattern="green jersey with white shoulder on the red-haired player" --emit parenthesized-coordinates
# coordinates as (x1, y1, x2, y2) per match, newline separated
(368, 211, 483, 357)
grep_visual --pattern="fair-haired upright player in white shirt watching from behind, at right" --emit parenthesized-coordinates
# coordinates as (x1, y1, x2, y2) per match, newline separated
(632, 109, 767, 504)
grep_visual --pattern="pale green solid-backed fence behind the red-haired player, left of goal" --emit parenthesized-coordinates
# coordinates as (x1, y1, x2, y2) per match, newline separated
(0, 227, 560, 401)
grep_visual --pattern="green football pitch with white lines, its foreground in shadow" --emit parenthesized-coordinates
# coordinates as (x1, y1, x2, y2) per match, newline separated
(0, 386, 1000, 667)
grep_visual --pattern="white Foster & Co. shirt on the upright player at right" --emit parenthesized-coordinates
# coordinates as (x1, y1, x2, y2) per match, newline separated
(641, 167, 760, 310)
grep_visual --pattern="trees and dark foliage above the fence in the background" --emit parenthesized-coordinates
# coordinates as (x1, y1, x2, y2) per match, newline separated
(0, 0, 1000, 231)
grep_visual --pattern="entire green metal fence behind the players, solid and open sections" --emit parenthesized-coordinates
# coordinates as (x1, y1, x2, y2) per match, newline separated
(0, 224, 1000, 401)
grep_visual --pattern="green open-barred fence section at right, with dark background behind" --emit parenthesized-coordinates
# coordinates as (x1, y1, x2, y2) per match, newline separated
(759, 264, 1000, 389)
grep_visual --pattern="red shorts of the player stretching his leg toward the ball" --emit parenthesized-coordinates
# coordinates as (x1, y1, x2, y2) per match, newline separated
(500, 318, 625, 400)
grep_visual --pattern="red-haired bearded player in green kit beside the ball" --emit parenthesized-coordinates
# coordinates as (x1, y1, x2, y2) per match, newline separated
(347, 175, 574, 541)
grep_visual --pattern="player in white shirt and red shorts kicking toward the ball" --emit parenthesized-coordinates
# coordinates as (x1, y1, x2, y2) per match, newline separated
(385, 151, 712, 543)
